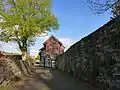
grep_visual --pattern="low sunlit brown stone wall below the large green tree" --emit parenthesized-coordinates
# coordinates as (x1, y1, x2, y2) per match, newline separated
(0, 58, 31, 85)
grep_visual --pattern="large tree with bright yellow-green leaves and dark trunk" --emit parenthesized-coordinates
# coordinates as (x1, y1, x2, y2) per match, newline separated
(0, 0, 59, 60)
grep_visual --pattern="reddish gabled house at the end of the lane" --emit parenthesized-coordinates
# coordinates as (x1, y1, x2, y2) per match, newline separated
(39, 35, 65, 67)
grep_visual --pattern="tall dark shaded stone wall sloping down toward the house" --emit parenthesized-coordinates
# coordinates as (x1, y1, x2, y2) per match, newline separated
(56, 18, 120, 88)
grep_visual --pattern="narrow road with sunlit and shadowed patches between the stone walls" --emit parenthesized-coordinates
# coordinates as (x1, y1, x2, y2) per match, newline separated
(12, 68, 96, 90)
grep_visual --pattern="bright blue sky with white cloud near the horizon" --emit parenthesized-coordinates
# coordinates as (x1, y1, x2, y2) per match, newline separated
(0, 0, 111, 56)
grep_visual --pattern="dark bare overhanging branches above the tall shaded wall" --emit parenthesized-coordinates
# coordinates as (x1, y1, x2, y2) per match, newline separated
(87, 0, 120, 17)
